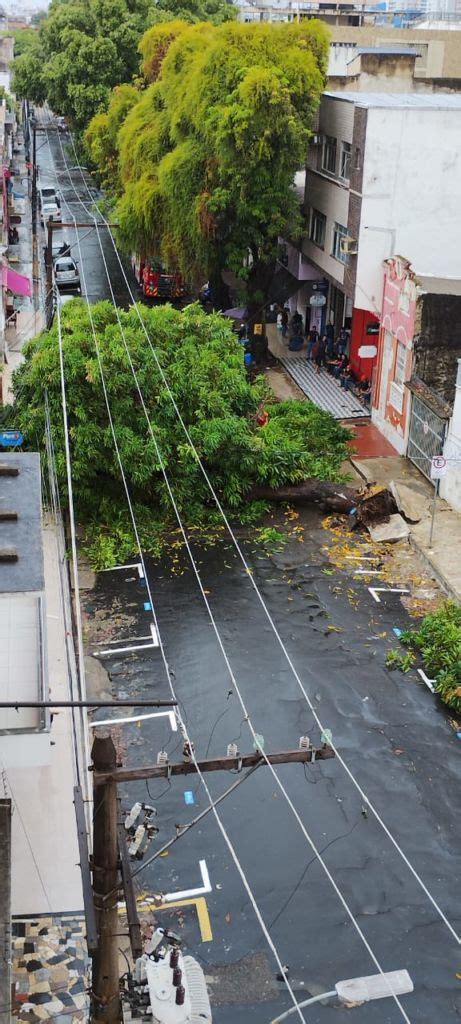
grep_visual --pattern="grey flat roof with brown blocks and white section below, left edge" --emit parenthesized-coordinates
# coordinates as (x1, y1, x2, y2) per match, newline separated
(0, 452, 49, 768)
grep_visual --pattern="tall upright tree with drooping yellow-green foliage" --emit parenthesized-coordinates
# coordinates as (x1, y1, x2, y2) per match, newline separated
(86, 20, 328, 319)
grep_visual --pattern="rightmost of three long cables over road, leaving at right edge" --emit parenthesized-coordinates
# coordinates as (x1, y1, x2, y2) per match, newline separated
(64, 135, 461, 944)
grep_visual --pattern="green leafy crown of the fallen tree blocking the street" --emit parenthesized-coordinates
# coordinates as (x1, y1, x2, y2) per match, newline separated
(10, 299, 349, 567)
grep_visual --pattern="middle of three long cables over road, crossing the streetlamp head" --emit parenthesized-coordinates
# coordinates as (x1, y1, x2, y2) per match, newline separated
(51, 140, 409, 1022)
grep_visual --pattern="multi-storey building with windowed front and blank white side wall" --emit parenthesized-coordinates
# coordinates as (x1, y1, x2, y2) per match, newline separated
(289, 87, 461, 385)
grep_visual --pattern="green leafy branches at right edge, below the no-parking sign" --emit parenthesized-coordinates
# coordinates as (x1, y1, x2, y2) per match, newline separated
(390, 601, 461, 714)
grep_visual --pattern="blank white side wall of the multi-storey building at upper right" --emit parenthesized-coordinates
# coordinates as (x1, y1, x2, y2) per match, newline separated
(355, 106, 461, 315)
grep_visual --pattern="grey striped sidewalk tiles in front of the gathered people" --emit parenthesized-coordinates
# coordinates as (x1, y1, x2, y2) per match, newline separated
(280, 355, 370, 420)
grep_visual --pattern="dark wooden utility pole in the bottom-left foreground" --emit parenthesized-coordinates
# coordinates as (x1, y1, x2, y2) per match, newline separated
(91, 729, 121, 1024)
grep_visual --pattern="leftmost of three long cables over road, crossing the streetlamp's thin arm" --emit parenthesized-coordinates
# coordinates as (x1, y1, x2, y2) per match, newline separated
(40, 155, 305, 1024)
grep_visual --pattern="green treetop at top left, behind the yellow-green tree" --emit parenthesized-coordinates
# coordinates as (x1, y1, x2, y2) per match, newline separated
(13, 0, 233, 131)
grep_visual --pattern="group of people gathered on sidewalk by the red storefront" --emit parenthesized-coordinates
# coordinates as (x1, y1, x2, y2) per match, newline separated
(277, 307, 371, 406)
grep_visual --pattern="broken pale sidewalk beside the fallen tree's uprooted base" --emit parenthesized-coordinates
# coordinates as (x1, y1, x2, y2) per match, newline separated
(350, 455, 461, 602)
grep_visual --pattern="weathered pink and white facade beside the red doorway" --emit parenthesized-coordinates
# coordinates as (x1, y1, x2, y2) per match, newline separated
(372, 257, 418, 455)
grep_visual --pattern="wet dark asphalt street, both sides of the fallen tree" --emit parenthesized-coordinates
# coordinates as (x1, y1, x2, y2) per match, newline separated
(39, 123, 461, 1024)
